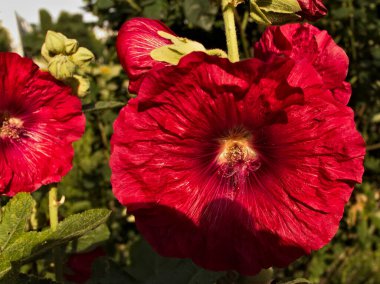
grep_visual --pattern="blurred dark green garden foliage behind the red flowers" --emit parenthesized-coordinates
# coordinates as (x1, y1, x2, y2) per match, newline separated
(0, 0, 380, 284)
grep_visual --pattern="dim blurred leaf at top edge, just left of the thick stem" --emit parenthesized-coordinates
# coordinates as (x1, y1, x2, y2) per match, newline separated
(183, 0, 218, 31)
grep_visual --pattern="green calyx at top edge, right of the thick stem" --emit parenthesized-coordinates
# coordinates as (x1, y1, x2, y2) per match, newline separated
(250, 0, 301, 25)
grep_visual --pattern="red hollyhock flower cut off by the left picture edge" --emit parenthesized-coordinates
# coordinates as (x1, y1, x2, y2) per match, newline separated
(0, 52, 85, 196)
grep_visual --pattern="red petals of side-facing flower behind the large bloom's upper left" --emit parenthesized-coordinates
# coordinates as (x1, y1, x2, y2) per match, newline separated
(116, 18, 175, 93)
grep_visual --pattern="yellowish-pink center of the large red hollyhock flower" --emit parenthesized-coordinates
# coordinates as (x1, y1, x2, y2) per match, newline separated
(216, 128, 261, 181)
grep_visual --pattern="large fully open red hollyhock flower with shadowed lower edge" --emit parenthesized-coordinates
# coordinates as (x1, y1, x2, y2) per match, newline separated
(110, 53, 365, 274)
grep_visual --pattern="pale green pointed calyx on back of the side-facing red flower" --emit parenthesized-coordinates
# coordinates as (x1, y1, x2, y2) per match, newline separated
(150, 31, 227, 65)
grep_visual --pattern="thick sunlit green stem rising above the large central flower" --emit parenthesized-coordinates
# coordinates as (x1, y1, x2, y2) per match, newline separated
(222, 0, 239, 62)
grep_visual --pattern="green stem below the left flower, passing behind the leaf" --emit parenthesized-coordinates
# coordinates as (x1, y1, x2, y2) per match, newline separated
(49, 186, 63, 283)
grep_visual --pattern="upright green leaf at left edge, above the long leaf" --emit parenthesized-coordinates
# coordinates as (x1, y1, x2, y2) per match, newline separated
(0, 193, 34, 253)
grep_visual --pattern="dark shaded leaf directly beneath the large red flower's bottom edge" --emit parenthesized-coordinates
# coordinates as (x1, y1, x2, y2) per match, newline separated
(127, 240, 225, 284)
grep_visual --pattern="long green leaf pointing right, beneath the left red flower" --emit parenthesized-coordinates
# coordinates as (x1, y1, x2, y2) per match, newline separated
(0, 209, 111, 275)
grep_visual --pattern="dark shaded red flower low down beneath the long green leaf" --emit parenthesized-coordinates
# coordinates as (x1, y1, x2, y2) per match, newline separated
(65, 248, 106, 284)
